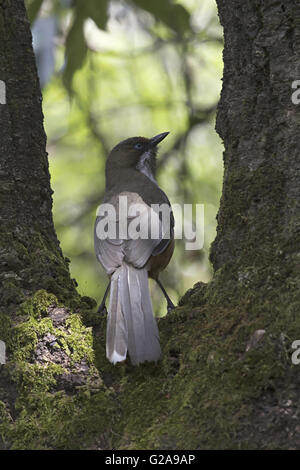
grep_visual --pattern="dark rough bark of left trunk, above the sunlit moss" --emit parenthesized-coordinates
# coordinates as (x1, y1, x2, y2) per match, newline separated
(0, 0, 75, 310)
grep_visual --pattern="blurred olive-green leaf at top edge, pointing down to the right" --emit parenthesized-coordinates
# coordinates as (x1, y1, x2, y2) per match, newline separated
(133, 0, 190, 34)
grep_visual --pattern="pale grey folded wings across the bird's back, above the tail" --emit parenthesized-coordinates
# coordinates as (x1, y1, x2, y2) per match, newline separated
(94, 192, 174, 274)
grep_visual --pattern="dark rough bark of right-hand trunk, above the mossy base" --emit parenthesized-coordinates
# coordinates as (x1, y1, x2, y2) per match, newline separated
(211, 0, 300, 288)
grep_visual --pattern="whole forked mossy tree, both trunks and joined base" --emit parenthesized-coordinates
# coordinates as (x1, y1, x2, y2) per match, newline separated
(0, 0, 300, 449)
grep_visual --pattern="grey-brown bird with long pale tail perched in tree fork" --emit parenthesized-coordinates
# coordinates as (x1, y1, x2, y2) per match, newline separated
(94, 132, 175, 365)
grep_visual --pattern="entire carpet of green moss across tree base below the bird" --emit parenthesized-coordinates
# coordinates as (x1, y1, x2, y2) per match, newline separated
(0, 266, 300, 450)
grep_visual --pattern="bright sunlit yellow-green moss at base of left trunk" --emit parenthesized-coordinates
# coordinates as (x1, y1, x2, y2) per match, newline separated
(0, 290, 112, 449)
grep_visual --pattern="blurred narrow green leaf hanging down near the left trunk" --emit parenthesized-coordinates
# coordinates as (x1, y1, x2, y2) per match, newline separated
(63, 14, 87, 93)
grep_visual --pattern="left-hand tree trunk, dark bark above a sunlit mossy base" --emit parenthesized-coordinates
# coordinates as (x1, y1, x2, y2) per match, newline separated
(0, 0, 103, 448)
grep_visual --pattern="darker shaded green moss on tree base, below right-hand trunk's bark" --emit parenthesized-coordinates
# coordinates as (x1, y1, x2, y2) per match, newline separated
(100, 271, 300, 449)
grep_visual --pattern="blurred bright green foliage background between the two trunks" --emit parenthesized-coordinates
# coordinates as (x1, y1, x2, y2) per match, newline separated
(29, 0, 223, 314)
